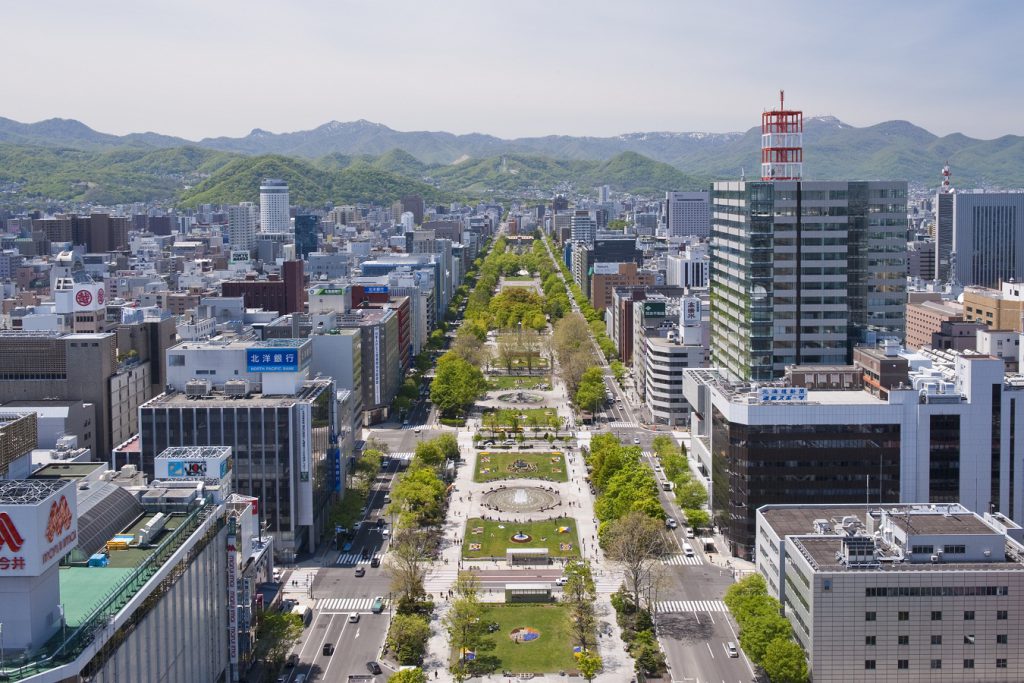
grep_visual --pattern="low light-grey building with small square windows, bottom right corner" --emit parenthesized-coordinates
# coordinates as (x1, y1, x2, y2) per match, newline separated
(757, 503, 1024, 683)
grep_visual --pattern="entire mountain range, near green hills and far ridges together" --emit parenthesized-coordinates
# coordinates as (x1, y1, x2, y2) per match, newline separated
(0, 117, 1024, 208)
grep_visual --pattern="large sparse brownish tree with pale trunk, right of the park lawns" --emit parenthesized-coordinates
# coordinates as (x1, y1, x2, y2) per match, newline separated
(601, 512, 667, 607)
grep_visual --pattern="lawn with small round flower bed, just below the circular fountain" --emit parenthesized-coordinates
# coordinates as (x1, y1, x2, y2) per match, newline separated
(462, 517, 580, 559)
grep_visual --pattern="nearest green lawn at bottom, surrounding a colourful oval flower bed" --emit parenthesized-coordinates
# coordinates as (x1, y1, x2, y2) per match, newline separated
(460, 604, 575, 674)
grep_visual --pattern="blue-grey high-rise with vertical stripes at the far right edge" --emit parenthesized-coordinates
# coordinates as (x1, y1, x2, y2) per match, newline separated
(939, 193, 1024, 288)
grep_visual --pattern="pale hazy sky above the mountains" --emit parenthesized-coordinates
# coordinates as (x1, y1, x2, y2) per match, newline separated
(0, 0, 1024, 139)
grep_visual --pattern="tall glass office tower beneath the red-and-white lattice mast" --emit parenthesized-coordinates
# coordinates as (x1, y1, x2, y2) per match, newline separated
(711, 180, 906, 380)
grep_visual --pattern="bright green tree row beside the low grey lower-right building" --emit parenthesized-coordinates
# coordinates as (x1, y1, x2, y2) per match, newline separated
(725, 573, 808, 683)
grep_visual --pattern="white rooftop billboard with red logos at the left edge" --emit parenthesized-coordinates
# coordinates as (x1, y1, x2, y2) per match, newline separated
(0, 481, 78, 577)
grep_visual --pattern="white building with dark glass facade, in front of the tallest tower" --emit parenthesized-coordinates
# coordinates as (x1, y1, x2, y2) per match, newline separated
(683, 344, 1024, 557)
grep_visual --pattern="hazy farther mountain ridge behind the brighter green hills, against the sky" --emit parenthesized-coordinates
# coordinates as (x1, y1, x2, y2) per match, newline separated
(0, 117, 1024, 188)
